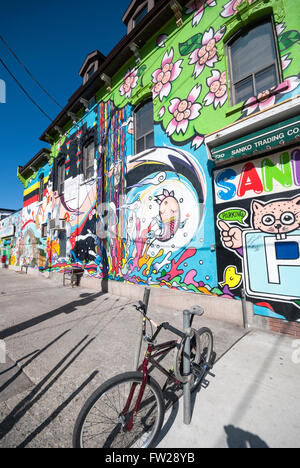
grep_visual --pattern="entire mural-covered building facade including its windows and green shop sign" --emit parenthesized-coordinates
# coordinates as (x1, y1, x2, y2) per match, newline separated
(15, 0, 300, 334)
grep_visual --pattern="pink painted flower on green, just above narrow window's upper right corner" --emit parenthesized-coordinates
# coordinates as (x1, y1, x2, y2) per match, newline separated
(152, 48, 182, 101)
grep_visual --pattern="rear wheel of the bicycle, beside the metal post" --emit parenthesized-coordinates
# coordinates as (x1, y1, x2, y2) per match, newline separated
(174, 327, 213, 391)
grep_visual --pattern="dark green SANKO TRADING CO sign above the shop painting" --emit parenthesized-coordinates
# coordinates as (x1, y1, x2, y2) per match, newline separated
(211, 117, 300, 161)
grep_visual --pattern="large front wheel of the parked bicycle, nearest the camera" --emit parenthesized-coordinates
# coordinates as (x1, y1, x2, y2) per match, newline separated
(73, 372, 165, 448)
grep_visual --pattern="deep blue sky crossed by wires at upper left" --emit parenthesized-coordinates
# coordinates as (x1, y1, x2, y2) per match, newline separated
(0, 0, 130, 209)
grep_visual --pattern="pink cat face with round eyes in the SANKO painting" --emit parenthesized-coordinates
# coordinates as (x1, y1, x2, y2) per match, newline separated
(252, 196, 300, 234)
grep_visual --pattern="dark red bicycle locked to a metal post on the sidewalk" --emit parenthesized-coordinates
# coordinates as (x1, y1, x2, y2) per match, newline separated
(73, 292, 213, 448)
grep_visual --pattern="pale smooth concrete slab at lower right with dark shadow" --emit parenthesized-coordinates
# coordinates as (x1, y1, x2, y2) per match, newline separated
(157, 330, 300, 448)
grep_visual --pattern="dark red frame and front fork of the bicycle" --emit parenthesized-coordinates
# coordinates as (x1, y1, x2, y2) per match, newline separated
(121, 330, 178, 431)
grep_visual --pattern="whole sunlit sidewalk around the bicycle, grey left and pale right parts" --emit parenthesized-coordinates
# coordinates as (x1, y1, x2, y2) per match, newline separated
(0, 270, 299, 448)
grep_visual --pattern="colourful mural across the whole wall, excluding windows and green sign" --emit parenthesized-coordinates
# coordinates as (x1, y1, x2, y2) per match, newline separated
(15, 0, 300, 326)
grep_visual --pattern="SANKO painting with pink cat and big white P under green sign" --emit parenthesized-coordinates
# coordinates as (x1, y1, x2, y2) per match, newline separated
(215, 148, 300, 321)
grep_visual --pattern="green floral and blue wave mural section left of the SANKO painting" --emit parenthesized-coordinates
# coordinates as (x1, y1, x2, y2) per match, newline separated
(92, 0, 300, 314)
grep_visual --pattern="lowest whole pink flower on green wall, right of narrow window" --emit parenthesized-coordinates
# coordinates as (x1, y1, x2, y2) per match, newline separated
(166, 85, 202, 136)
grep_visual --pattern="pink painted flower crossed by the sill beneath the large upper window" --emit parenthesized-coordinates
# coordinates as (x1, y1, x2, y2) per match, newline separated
(244, 76, 300, 115)
